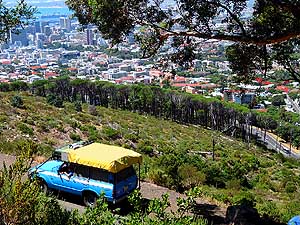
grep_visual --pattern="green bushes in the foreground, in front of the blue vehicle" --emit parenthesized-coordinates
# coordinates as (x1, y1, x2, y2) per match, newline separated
(0, 141, 207, 225)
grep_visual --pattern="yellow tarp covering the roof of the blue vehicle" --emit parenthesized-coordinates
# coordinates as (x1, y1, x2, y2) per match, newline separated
(67, 143, 142, 173)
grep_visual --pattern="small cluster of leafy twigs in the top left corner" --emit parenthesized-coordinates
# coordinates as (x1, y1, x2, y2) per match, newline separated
(0, 0, 36, 42)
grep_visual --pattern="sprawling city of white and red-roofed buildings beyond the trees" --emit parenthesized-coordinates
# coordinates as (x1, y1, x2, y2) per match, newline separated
(0, 8, 299, 115)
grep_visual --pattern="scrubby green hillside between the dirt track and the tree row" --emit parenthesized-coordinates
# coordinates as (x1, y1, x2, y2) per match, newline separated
(0, 92, 300, 222)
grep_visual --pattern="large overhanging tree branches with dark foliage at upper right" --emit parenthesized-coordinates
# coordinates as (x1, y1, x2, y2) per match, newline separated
(66, 0, 300, 80)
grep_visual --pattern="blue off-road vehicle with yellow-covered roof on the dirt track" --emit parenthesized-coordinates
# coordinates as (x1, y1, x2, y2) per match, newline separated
(29, 143, 142, 207)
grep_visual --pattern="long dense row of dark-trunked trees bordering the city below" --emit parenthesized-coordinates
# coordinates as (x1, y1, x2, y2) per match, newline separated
(0, 77, 277, 141)
